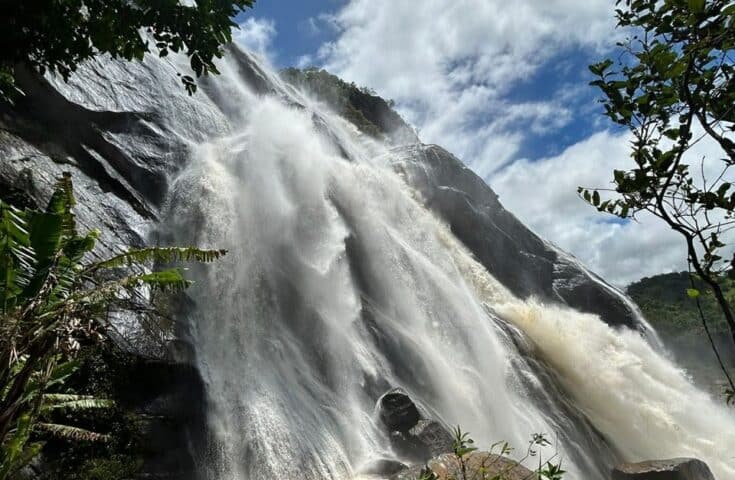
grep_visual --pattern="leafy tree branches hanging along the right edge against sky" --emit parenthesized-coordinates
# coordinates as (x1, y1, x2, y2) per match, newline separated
(578, 0, 735, 382)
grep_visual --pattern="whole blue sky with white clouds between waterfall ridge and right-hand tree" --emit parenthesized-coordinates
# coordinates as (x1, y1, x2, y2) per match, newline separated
(235, 0, 686, 287)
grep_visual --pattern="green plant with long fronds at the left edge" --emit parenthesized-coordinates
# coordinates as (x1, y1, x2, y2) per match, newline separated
(0, 174, 225, 480)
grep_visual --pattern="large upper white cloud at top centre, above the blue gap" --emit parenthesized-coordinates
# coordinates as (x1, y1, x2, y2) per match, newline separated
(320, 0, 614, 173)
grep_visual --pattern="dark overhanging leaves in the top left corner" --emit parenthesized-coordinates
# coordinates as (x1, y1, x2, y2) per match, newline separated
(0, 0, 255, 99)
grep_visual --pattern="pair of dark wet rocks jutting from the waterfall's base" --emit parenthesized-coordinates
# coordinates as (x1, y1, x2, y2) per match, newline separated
(378, 389, 453, 462)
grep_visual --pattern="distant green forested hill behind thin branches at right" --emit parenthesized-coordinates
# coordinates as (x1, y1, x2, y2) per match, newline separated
(627, 272, 735, 393)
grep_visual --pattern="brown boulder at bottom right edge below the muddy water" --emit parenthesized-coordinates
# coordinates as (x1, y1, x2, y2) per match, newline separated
(612, 458, 715, 480)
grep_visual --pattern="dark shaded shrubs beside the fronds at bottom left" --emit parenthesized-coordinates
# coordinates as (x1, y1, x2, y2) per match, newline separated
(35, 342, 157, 480)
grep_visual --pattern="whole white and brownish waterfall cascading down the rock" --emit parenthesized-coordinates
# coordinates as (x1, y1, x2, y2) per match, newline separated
(162, 50, 735, 480)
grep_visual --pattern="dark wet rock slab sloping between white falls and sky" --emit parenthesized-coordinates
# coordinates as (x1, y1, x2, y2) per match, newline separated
(389, 145, 641, 328)
